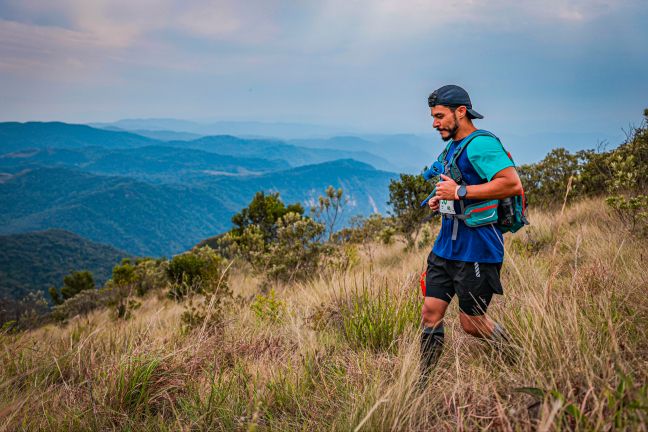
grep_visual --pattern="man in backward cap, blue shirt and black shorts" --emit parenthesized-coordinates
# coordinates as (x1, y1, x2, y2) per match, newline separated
(421, 85, 522, 377)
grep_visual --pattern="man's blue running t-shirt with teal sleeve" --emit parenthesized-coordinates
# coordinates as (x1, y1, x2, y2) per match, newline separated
(432, 136, 515, 263)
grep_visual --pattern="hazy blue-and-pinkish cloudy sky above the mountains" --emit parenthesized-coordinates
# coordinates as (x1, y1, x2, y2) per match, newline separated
(0, 0, 648, 142)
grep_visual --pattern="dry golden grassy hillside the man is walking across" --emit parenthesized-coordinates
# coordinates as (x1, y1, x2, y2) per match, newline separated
(0, 200, 648, 431)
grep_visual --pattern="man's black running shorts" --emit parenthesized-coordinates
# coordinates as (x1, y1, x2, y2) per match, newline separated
(425, 252, 504, 316)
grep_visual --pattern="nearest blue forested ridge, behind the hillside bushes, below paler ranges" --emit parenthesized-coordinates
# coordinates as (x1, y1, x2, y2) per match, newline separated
(0, 160, 396, 256)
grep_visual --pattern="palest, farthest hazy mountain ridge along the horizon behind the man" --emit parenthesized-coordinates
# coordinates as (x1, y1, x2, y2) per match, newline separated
(88, 119, 625, 168)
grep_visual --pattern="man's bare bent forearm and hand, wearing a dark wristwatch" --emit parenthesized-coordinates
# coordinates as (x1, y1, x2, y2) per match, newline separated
(436, 167, 522, 200)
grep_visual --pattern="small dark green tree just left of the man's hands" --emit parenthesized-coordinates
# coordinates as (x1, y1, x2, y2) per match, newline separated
(387, 170, 434, 248)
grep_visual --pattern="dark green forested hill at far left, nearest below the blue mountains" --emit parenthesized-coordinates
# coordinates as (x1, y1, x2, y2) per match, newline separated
(0, 229, 128, 299)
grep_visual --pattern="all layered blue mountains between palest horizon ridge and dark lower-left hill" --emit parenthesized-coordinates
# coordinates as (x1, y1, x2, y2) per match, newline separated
(0, 123, 396, 256)
